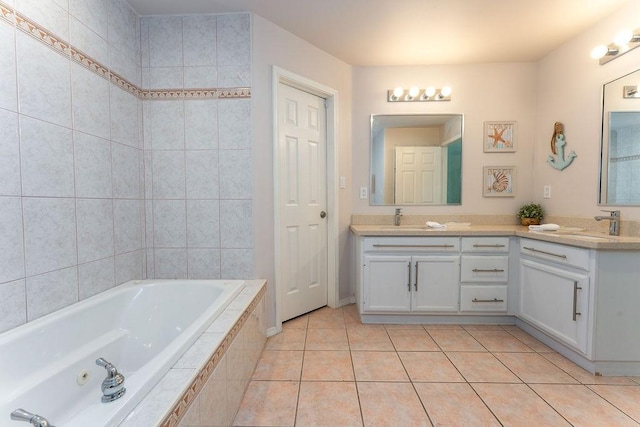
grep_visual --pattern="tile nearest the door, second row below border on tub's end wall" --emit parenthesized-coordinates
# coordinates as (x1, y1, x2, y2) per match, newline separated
(220, 150, 254, 199)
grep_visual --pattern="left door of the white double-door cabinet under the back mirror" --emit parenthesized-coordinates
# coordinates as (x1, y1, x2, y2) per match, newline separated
(362, 255, 411, 312)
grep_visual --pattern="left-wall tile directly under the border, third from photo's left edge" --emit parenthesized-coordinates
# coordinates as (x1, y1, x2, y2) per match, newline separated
(71, 63, 111, 138)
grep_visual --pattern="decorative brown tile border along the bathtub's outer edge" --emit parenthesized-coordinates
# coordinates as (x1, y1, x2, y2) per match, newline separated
(159, 283, 267, 427)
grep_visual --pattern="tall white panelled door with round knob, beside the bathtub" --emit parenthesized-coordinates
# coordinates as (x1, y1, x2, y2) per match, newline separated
(276, 83, 328, 322)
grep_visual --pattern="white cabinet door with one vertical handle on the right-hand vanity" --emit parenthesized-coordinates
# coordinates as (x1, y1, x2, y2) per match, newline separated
(520, 260, 589, 354)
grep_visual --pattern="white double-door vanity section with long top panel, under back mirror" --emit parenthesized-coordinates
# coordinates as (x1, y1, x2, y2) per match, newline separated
(358, 237, 460, 313)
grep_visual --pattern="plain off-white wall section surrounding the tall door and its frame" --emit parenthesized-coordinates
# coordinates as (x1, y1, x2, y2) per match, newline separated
(251, 15, 352, 326)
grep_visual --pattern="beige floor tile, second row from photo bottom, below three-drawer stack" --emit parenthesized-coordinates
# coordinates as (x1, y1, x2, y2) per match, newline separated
(446, 352, 521, 383)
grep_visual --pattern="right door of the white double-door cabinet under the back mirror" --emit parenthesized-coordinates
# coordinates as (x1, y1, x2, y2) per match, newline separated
(411, 256, 460, 311)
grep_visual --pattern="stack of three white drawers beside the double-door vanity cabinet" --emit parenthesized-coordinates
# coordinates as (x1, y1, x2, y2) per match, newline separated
(460, 237, 509, 312)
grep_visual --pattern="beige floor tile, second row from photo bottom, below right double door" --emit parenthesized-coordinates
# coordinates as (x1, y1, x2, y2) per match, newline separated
(398, 351, 464, 382)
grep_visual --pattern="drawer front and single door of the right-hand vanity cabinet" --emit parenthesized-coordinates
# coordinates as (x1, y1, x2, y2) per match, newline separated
(519, 239, 595, 356)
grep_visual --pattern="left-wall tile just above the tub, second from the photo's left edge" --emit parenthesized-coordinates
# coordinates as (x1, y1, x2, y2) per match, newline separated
(27, 266, 78, 321)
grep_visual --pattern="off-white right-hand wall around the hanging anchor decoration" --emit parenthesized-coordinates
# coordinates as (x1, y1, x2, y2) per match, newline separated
(533, 1, 640, 220)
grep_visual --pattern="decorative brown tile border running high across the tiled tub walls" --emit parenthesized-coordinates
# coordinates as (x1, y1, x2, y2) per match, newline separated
(0, 1, 251, 100)
